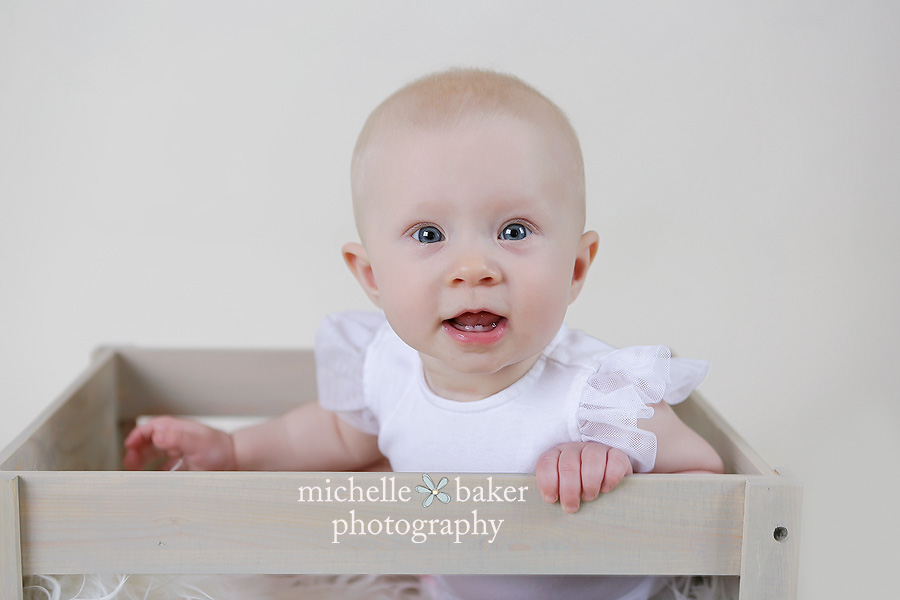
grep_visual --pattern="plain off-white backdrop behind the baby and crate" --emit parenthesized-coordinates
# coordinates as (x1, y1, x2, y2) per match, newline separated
(0, 0, 900, 599)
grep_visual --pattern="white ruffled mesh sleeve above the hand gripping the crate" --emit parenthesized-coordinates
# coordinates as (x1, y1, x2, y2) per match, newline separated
(576, 346, 709, 473)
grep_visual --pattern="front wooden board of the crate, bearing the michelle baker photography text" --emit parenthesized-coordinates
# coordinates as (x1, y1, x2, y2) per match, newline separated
(15, 472, 745, 575)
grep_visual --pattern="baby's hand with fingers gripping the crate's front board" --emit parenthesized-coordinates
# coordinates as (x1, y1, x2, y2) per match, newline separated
(535, 442, 634, 513)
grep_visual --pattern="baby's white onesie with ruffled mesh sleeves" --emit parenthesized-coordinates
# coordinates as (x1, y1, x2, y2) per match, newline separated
(315, 312, 709, 599)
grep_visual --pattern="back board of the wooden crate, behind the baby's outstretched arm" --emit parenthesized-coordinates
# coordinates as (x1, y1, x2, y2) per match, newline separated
(116, 348, 316, 419)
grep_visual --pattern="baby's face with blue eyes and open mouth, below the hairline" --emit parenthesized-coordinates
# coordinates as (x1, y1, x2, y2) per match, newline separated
(352, 116, 596, 395)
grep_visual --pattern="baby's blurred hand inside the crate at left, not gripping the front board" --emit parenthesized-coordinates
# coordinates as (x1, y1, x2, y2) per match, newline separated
(122, 417, 237, 471)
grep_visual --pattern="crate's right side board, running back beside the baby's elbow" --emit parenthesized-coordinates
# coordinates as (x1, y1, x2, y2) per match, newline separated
(673, 392, 774, 475)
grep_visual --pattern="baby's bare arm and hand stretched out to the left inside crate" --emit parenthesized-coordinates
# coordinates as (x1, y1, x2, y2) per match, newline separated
(123, 402, 383, 471)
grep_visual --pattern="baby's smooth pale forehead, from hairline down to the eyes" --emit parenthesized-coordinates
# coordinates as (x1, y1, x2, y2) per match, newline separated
(356, 123, 584, 230)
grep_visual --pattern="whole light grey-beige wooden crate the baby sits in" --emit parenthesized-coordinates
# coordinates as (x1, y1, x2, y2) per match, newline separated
(0, 347, 801, 600)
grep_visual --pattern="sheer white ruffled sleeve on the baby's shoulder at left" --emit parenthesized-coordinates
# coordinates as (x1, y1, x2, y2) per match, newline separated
(315, 312, 385, 435)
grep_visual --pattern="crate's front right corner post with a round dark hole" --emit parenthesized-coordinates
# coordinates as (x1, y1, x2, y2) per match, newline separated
(740, 477, 802, 600)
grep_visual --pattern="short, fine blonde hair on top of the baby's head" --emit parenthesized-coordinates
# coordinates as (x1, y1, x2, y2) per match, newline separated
(350, 69, 585, 233)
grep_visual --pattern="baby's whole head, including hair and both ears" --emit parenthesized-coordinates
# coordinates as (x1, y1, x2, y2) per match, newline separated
(344, 70, 598, 397)
